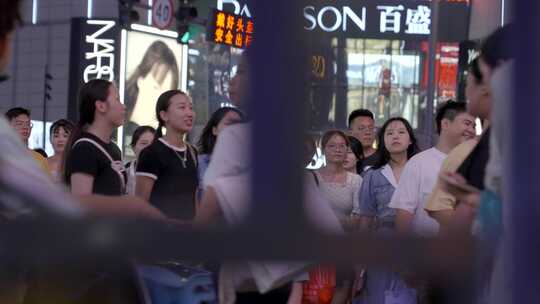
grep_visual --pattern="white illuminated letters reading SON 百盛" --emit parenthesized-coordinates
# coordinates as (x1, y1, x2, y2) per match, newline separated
(304, 4, 431, 35)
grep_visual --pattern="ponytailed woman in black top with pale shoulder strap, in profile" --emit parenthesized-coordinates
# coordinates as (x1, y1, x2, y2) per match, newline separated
(64, 79, 125, 195)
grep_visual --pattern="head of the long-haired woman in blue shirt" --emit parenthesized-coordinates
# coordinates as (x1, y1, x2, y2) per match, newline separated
(374, 117, 419, 168)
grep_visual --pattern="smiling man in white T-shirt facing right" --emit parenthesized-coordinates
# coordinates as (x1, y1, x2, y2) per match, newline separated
(390, 101, 475, 237)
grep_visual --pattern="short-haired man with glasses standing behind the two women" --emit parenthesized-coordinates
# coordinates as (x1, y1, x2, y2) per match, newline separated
(349, 109, 377, 171)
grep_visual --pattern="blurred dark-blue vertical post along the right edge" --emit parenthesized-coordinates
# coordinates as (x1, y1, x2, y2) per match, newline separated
(510, 0, 540, 303)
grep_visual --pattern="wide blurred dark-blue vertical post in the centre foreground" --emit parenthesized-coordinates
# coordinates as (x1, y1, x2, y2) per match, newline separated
(250, 0, 310, 233)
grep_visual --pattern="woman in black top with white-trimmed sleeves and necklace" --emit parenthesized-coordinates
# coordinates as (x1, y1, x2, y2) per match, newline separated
(135, 90, 198, 220)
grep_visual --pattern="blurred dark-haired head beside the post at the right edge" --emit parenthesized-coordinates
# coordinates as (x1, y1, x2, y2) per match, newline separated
(479, 24, 514, 85)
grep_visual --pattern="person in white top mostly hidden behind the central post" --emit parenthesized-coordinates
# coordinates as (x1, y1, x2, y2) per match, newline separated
(198, 53, 343, 303)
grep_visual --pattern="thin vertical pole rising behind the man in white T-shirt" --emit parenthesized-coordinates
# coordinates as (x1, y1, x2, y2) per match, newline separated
(424, 0, 439, 146)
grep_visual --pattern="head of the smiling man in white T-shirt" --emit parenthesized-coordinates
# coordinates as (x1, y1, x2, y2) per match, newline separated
(436, 100, 476, 146)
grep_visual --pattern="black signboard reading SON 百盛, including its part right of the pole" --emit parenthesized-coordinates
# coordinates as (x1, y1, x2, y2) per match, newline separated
(303, 0, 469, 41)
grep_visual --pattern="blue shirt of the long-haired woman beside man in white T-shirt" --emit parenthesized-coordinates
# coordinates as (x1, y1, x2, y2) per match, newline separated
(358, 165, 397, 227)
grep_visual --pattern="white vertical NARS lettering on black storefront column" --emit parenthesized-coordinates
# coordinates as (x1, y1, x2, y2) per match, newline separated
(83, 20, 116, 82)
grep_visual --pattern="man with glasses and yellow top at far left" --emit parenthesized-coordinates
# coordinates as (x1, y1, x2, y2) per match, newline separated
(5, 107, 50, 174)
